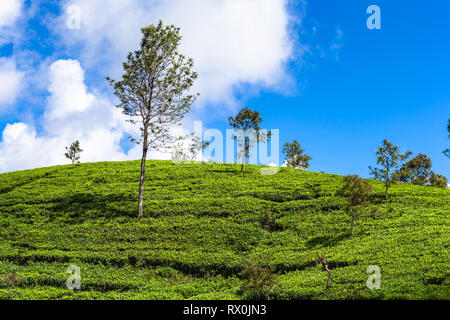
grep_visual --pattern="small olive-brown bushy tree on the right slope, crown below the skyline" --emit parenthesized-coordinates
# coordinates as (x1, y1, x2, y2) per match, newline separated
(337, 175, 373, 234)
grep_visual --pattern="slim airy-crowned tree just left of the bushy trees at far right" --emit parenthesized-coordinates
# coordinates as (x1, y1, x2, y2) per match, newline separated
(369, 139, 411, 199)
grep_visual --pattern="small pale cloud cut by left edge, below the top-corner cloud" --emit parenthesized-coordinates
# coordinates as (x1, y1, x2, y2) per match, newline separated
(0, 58, 23, 110)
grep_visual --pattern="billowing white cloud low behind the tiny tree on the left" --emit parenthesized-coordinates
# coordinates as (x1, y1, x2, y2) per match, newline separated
(0, 60, 132, 172)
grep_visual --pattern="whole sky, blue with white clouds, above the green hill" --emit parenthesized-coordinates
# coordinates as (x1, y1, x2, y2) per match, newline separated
(0, 0, 450, 177)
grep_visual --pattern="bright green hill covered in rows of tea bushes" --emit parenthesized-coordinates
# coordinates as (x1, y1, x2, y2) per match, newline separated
(0, 161, 450, 299)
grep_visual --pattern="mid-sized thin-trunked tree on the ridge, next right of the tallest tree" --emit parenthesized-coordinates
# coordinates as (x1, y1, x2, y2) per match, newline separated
(228, 107, 271, 173)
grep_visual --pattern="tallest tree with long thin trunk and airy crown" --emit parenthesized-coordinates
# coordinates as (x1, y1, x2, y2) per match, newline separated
(107, 21, 197, 218)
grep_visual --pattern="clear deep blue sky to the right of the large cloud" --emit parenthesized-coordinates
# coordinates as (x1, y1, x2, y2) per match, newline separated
(206, 0, 450, 177)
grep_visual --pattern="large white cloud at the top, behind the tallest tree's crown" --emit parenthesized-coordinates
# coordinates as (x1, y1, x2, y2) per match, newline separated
(58, 0, 293, 105)
